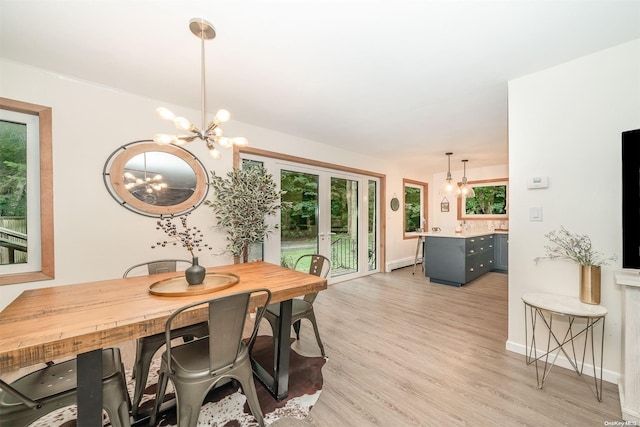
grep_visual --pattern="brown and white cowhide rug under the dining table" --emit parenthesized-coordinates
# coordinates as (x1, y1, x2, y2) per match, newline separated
(32, 336, 326, 427)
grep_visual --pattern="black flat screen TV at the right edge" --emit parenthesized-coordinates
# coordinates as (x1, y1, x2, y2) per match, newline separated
(622, 129, 640, 269)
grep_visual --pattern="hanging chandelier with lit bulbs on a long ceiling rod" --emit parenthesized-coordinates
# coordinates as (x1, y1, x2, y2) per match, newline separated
(153, 18, 249, 160)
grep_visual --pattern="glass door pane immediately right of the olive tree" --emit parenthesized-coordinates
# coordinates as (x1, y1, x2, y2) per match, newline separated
(280, 169, 319, 268)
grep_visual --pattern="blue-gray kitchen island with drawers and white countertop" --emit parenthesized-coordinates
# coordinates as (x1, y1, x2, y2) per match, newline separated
(423, 233, 506, 286)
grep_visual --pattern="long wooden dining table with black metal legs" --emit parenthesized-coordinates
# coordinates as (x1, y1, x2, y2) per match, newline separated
(0, 262, 327, 427)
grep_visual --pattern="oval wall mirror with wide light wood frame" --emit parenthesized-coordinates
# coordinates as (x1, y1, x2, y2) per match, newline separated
(102, 140, 209, 217)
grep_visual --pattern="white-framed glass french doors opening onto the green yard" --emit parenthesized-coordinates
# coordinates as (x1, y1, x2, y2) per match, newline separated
(242, 155, 379, 283)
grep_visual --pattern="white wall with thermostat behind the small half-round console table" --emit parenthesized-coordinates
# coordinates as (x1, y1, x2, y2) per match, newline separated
(507, 39, 640, 382)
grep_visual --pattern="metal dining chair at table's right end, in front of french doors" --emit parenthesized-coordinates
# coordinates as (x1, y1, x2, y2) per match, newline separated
(264, 254, 331, 357)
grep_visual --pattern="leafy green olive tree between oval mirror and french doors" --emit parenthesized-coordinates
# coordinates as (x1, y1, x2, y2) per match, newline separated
(205, 163, 283, 262)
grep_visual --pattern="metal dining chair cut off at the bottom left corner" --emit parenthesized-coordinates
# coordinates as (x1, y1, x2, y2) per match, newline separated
(0, 347, 131, 427)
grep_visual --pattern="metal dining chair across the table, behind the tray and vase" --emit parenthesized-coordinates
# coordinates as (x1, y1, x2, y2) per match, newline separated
(122, 259, 209, 417)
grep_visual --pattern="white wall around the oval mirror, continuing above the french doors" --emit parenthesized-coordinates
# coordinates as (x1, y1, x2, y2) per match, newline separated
(0, 58, 431, 309)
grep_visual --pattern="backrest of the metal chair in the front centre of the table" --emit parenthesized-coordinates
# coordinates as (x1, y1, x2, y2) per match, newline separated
(165, 289, 271, 375)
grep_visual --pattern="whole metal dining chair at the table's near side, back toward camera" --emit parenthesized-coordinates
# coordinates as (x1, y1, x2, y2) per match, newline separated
(150, 289, 271, 427)
